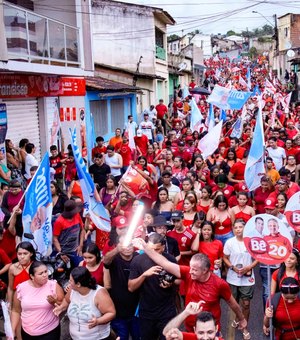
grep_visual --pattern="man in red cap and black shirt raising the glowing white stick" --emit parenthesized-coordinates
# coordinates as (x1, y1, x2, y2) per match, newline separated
(103, 237, 140, 340)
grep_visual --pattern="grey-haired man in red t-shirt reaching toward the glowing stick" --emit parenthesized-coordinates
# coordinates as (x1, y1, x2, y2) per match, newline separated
(134, 239, 247, 332)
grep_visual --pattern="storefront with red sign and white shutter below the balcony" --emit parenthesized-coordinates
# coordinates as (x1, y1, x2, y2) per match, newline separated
(0, 74, 85, 160)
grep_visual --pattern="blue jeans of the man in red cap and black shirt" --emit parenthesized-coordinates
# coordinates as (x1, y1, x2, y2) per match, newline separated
(110, 316, 141, 340)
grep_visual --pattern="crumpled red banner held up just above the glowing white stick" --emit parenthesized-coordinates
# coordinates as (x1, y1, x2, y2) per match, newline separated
(122, 166, 150, 199)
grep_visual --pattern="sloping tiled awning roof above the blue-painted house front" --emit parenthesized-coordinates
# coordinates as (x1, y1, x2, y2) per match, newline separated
(85, 77, 141, 92)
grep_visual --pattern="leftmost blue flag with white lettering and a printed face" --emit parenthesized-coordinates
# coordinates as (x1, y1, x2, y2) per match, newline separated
(22, 152, 53, 255)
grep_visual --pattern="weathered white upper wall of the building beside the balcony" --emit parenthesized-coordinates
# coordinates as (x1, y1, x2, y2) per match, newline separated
(92, 3, 155, 74)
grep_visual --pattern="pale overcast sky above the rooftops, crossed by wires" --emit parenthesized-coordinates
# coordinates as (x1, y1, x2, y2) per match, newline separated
(127, 0, 300, 36)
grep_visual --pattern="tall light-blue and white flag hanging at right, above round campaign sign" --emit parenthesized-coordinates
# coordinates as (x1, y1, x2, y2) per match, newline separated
(245, 98, 266, 191)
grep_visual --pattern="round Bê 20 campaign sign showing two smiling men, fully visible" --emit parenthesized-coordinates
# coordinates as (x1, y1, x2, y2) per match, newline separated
(244, 214, 293, 264)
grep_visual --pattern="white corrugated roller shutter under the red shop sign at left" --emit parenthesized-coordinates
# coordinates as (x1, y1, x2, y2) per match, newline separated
(3, 98, 41, 161)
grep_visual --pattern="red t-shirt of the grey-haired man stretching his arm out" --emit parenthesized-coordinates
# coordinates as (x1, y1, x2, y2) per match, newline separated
(180, 266, 232, 332)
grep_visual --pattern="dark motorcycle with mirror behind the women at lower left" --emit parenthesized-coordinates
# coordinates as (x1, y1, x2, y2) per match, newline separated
(24, 233, 71, 292)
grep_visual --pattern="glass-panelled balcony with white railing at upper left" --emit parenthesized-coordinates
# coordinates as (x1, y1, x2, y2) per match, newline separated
(3, 3, 81, 67)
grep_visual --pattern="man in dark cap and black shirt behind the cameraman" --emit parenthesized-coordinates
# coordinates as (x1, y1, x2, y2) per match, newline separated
(149, 215, 180, 261)
